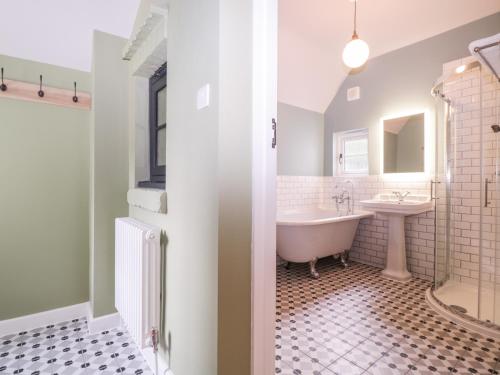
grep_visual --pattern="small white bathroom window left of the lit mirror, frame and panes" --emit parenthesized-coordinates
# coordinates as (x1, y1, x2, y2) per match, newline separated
(333, 129, 368, 175)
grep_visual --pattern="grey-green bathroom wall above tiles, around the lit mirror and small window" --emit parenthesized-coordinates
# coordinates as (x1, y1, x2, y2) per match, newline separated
(324, 13, 500, 175)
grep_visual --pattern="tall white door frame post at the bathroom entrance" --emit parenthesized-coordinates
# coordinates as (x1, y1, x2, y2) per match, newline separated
(251, 0, 279, 375)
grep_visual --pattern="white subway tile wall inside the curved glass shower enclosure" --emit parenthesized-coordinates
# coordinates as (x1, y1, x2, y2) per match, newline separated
(438, 57, 500, 287)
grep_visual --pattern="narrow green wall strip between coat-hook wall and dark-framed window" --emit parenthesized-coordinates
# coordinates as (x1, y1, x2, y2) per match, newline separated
(90, 31, 129, 317)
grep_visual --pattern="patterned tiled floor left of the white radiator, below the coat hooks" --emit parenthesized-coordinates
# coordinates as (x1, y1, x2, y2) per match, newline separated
(0, 318, 152, 375)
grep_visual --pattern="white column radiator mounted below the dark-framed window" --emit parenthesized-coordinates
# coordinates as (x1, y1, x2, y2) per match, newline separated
(115, 217, 161, 350)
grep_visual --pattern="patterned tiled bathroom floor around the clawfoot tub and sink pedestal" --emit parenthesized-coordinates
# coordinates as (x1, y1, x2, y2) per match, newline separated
(276, 259, 500, 375)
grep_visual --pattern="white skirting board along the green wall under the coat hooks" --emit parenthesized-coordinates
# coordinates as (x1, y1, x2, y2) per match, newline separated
(0, 302, 88, 337)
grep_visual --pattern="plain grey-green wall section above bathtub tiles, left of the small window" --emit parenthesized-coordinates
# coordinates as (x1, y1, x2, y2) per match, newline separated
(277, 103, 325, 176)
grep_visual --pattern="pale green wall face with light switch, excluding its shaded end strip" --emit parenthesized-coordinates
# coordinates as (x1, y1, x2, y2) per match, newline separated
(130, 0, 219, 375)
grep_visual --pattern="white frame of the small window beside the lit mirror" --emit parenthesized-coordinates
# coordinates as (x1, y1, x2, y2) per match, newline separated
(333, 128, 370, 176)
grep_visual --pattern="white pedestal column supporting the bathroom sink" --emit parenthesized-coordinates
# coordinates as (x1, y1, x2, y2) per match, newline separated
(382, 213, 411, 281)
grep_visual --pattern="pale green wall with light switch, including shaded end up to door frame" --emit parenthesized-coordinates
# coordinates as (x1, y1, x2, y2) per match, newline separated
(129, 0, 252, 375)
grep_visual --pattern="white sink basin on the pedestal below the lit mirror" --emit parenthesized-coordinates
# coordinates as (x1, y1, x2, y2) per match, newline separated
(359, 194, 432, 216)
